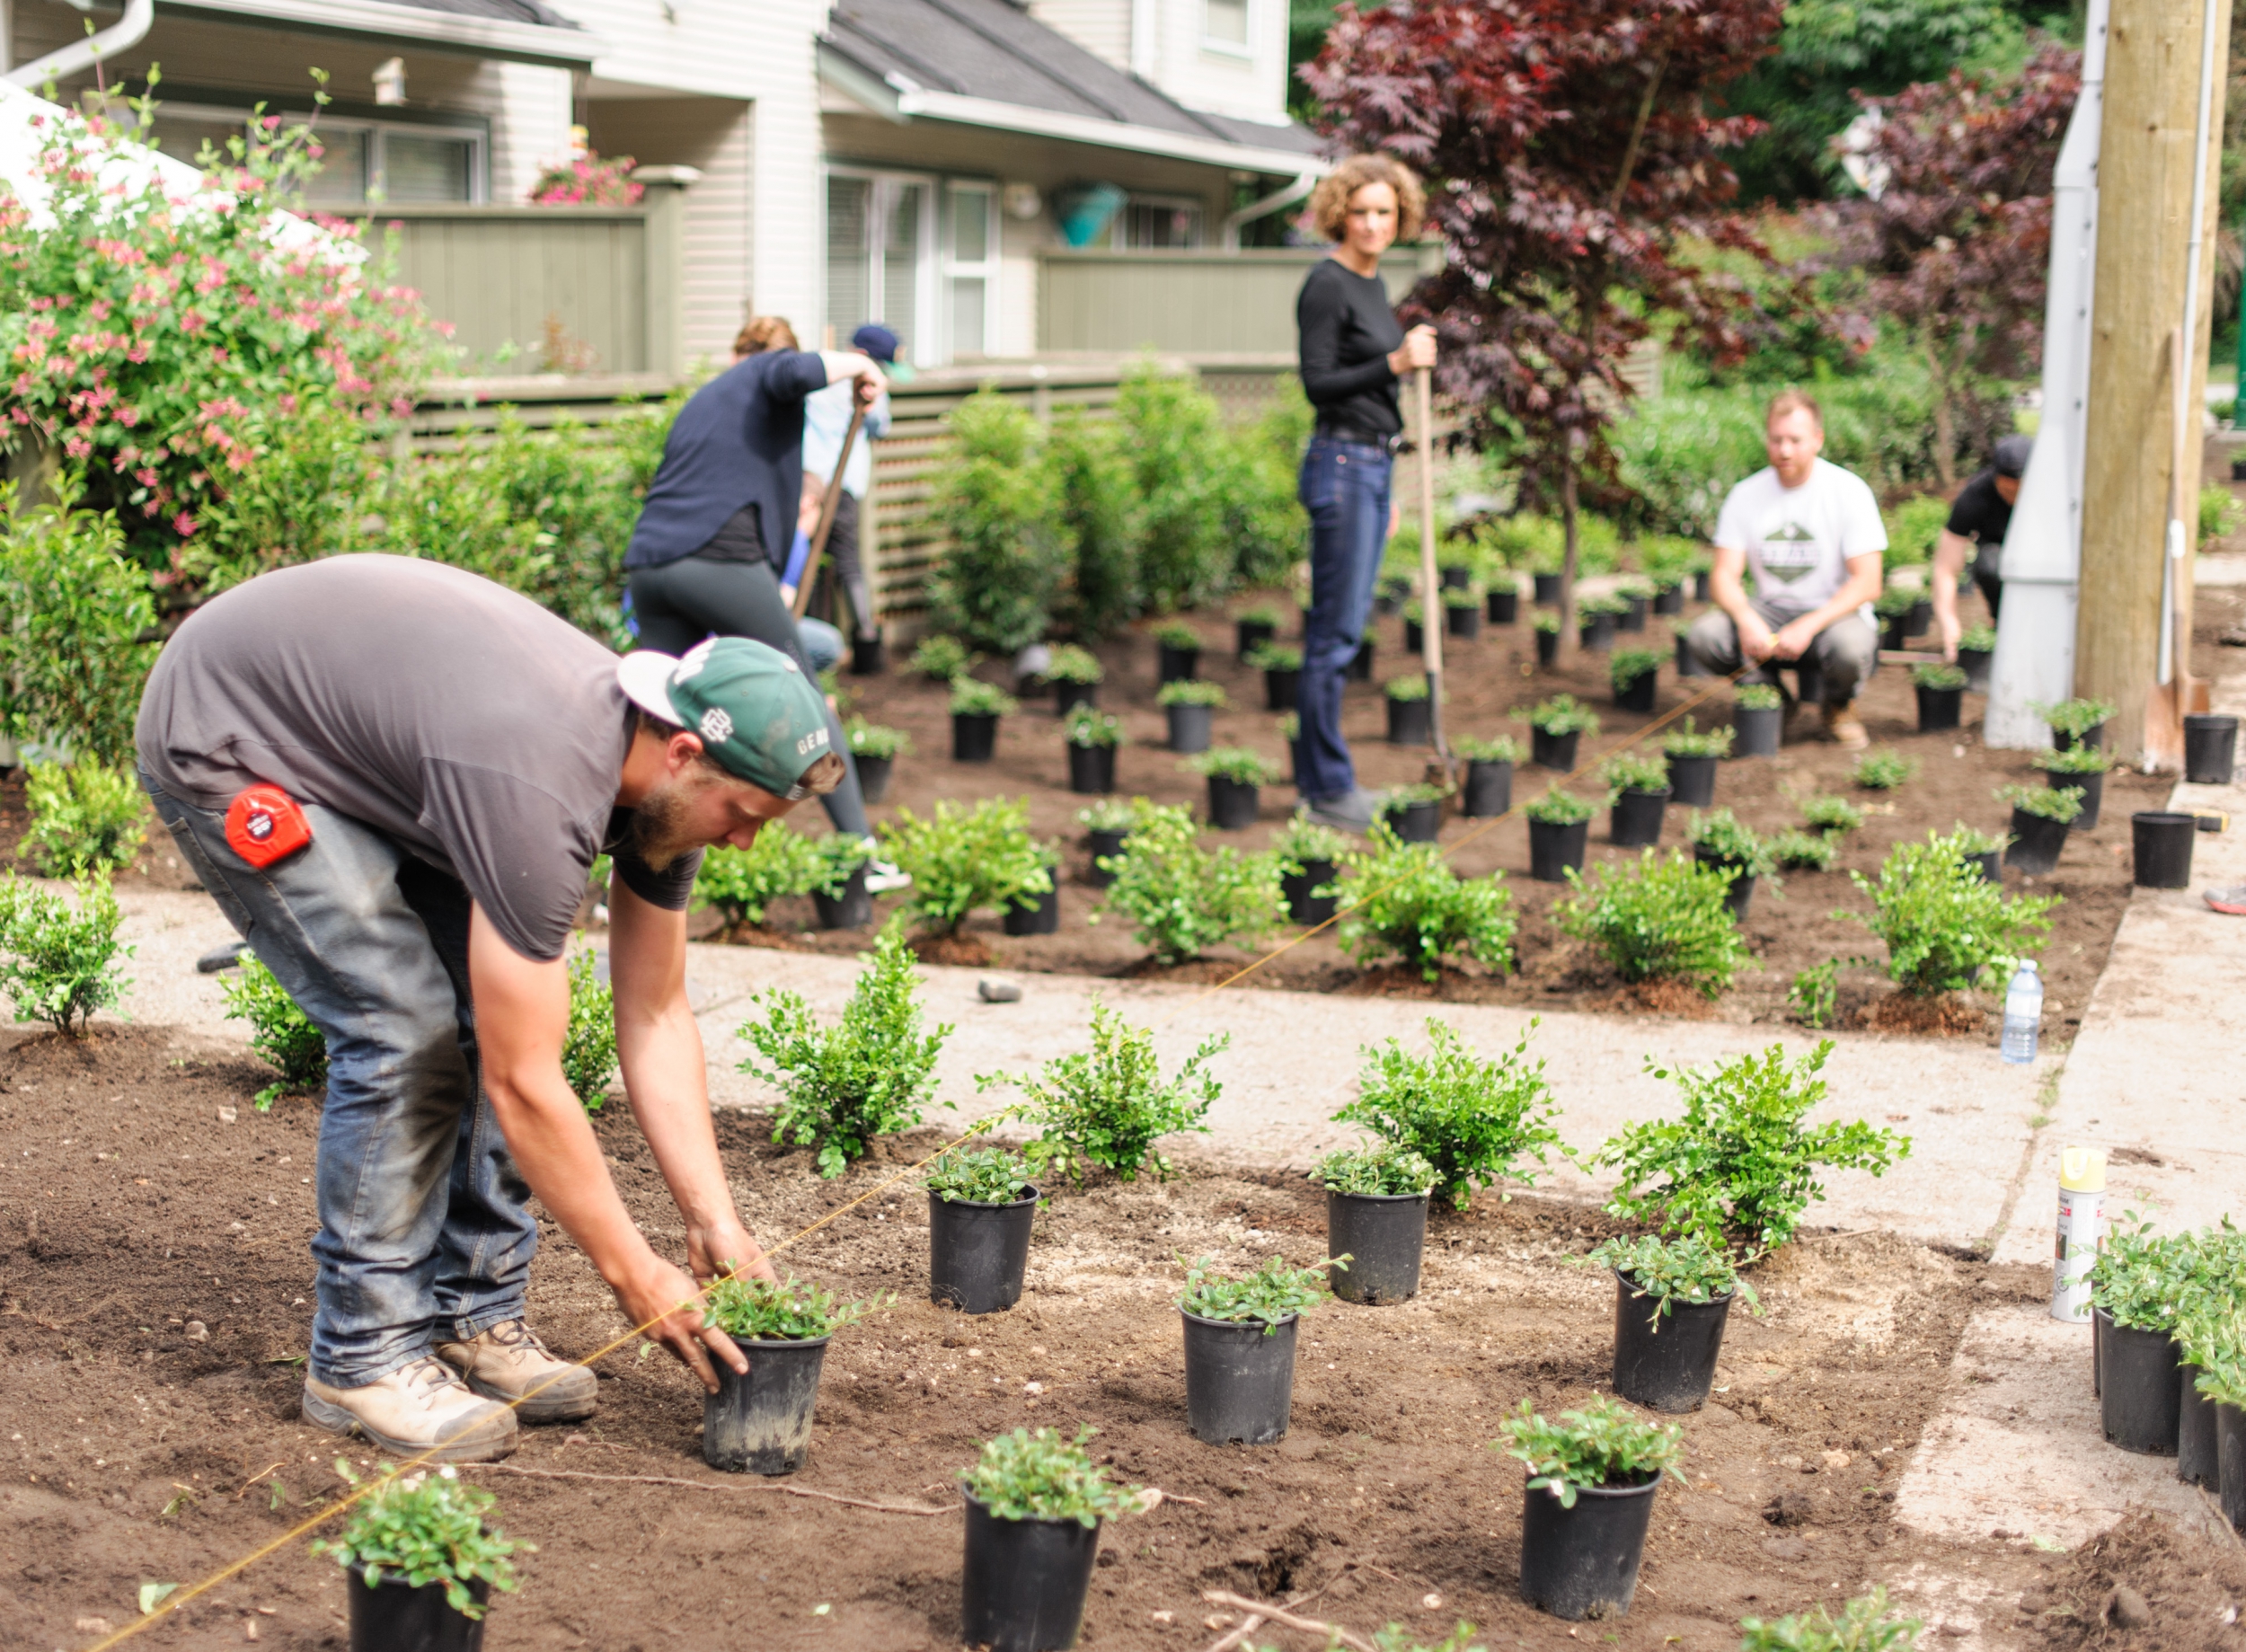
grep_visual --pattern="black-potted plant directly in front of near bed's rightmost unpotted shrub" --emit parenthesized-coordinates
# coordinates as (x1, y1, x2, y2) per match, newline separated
(1584, 1234, 1756, 1412)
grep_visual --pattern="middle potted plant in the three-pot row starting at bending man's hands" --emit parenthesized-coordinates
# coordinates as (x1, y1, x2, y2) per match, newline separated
(1177, 1257, 1350, 1445)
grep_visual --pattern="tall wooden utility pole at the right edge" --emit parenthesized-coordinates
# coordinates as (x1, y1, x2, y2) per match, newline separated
(2075, 0, 2231, 761)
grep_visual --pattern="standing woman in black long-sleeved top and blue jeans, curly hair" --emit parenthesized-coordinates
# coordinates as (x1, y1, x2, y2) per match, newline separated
(1294, 155, 1436, 833)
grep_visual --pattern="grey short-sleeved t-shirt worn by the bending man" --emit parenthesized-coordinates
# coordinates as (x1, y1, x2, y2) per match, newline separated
(135, 557, 701, 959)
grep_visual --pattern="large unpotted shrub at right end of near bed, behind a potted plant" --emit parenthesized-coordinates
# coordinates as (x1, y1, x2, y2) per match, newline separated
(1590, 1039, 1912, 1255)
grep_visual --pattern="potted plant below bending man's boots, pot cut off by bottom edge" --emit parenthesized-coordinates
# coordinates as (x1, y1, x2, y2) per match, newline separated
(313, 1457, 533, 1652)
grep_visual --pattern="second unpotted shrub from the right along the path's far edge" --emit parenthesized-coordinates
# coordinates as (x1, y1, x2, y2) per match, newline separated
(1552, 848, 1750, 999)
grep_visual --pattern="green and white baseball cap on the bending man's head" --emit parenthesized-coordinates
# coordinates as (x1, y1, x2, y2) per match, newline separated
(615, 638, 834, 801)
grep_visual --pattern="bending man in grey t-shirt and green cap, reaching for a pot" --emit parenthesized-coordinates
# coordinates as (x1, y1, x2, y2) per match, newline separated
(137, 557, 843, 1462)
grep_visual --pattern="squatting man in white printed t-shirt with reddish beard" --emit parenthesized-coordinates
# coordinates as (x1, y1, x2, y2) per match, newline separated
(1684, 391, 1887, 752)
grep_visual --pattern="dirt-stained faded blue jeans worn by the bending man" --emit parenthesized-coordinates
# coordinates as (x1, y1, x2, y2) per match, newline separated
(142, 770, 539, 1387)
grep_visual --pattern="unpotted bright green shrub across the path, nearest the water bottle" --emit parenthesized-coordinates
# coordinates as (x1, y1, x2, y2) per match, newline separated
(1833, 833, 2060, 999)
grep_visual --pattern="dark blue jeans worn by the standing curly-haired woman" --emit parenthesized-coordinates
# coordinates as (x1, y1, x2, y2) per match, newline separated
(1294, 436, 1391, 799)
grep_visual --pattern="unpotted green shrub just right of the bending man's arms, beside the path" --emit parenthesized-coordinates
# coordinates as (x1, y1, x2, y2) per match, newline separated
(735, 918, 952, 1176)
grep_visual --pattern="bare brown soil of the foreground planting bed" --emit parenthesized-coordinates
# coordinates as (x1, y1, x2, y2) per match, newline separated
(0, 1028, 2242, 1652)
